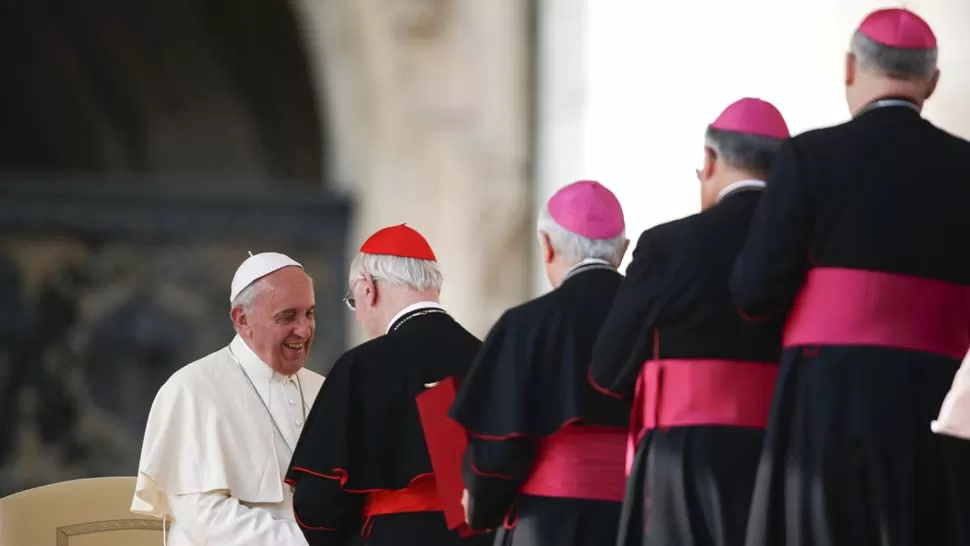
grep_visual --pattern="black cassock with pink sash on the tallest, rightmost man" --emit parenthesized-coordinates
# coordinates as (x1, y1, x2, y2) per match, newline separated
(731, 100, 970, 546)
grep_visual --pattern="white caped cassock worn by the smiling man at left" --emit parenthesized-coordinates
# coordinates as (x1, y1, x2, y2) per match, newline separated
(131, 336, 323, 546)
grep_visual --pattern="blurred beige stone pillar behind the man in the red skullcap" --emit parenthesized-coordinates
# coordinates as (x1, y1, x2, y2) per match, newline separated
(291, 0, 532, 339)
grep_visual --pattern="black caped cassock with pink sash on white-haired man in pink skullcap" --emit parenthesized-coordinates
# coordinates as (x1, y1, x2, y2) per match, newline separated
(451, 263, 629, 546)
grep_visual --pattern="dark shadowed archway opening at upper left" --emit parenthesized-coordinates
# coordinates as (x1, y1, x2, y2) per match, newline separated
(0, 0, 325, 184)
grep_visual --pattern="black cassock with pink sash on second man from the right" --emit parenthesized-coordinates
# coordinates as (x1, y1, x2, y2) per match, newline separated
(590, 188, 782, 546)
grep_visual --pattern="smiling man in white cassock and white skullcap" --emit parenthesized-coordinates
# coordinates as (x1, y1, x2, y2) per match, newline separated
(131, 252, 323, 546)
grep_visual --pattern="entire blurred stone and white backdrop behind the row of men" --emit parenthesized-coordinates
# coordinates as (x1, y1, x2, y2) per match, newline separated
(0, 0, 970, 496)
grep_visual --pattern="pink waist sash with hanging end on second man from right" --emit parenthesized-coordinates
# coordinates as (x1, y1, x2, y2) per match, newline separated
(626, 359, 778, 474)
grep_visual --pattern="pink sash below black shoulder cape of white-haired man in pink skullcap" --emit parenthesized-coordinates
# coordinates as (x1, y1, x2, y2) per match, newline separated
(520, 425, 626, 502)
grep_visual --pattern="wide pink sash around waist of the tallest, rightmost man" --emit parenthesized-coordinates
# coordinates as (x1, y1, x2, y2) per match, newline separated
(784, 267, 970, 360)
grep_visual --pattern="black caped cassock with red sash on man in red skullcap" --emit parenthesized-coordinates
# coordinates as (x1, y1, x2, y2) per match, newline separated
(286, 308, 492, 546)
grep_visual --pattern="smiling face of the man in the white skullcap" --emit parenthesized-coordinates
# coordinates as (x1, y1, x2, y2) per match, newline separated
(232, 267, 316, 375)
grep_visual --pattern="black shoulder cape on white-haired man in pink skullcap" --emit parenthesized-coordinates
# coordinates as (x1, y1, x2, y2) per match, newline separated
(450, 268, 630, 439)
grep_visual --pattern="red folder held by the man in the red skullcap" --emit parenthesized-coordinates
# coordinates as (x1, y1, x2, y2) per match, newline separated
(416, 377, 471, 536)
